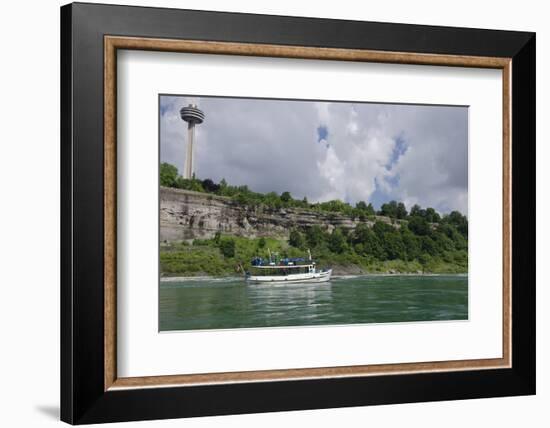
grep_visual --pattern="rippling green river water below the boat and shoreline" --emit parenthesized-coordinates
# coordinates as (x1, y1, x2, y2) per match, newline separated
(160, 275, 468, 331)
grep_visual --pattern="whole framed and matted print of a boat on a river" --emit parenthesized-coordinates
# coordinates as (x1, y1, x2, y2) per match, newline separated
(61, 3, 535, 424)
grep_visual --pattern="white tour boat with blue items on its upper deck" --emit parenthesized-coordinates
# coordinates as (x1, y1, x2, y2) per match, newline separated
(245, 250, 332, 284)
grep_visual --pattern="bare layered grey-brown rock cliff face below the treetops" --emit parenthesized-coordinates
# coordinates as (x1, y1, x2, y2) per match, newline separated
(160, 187, 396, 242)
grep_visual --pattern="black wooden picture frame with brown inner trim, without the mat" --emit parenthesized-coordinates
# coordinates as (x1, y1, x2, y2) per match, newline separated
(61, 4, 535, 424)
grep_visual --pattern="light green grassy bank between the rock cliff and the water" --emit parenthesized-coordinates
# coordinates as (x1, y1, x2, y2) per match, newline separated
(160, 237, 468, 276)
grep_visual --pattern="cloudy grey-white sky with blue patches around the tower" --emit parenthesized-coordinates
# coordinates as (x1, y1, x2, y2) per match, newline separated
(160, 95, 468, 214)
